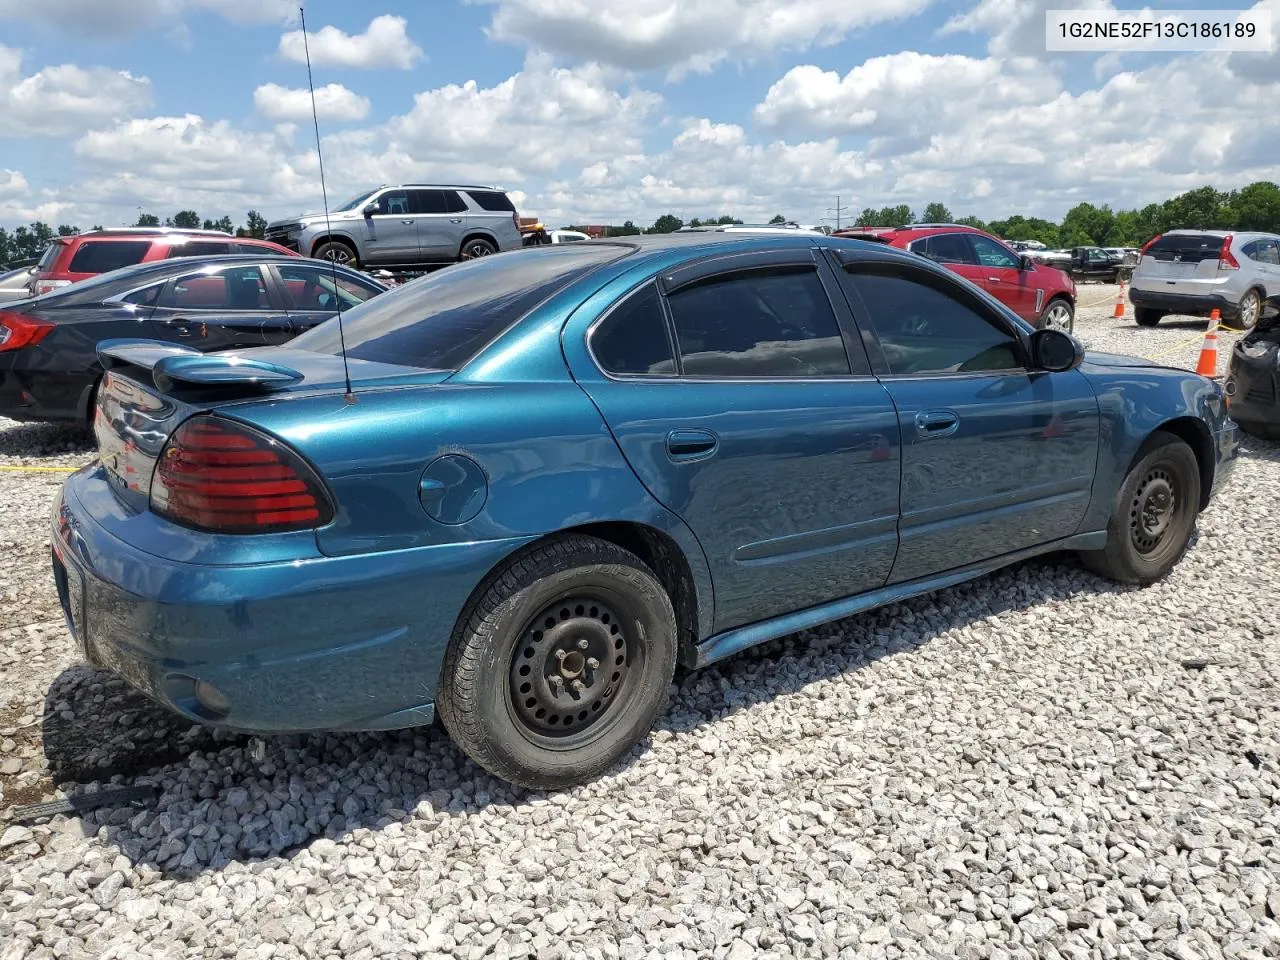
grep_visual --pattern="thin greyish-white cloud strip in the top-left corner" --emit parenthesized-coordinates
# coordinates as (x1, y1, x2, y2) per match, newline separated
(0, 0, 298, 36)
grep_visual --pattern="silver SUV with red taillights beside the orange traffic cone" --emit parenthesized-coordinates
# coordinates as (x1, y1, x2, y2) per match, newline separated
(1129, 230, 1280, 330)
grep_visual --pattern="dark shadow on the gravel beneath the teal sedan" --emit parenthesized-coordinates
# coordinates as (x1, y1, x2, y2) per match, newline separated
(44, 547, 1129, 878)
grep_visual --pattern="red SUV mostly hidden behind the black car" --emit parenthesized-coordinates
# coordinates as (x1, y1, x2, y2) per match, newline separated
(27, 227, 301, 297)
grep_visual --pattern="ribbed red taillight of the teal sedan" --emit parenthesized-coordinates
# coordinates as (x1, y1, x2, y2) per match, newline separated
(151, 415, 333, 534)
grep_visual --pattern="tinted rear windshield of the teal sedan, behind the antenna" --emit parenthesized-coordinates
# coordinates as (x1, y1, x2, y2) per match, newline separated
(289, 244, 626, 370)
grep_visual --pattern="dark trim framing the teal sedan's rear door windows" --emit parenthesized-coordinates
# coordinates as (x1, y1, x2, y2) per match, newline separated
(582, 256, 877, 384)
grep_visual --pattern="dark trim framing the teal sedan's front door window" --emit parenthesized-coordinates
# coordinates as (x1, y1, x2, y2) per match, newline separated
(831, 251, 1043, 381)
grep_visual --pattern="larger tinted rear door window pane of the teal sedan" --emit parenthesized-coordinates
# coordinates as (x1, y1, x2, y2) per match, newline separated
(668, 266, 850, 378)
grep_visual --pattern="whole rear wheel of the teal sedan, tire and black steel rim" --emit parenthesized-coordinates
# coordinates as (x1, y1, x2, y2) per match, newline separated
(436, 536, 676, 790)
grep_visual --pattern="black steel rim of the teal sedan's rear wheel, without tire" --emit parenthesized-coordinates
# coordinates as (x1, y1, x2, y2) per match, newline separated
(509, 594, 634, 746)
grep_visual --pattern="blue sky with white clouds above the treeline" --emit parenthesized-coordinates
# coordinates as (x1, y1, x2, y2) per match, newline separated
(0, 0, 1280, 228)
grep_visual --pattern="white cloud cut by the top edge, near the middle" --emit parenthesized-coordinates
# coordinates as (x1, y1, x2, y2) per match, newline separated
(471, 0, 933, 74)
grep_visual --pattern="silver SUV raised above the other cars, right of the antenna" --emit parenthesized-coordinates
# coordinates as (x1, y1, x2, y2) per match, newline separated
(266, 183, 522, 268)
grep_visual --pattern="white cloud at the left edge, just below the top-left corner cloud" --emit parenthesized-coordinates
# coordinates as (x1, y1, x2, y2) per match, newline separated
(0, 46, 151, 140)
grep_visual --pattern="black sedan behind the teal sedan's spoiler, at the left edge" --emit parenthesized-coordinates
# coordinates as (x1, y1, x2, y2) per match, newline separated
(0, 255, 387, 425)
